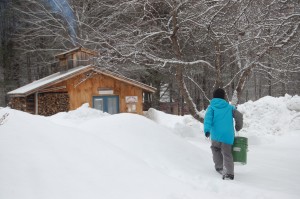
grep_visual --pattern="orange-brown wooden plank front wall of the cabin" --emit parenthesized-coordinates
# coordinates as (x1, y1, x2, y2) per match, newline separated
(50, 71, 143, 114)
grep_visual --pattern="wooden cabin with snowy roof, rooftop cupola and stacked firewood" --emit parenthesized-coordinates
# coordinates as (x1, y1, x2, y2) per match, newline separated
(8, 47, 156, 116)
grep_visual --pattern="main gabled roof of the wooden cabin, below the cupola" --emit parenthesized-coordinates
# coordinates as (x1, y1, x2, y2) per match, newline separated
(7, 65, 156, 97)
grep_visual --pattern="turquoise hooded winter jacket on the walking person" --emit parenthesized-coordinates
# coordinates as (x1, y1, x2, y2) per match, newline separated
(204, 98, 235, 145)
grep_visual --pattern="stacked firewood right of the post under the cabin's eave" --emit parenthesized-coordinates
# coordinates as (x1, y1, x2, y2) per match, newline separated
(38, 93, 69, 116)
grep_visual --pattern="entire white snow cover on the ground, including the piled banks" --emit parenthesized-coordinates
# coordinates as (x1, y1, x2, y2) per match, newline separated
(0, 95, 300, 199)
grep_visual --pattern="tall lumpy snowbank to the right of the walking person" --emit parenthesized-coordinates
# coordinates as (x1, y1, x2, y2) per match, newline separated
(238, 95, 300, 143)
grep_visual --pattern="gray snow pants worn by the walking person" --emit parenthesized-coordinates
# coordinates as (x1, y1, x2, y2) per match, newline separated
(210, 140, 234, 175)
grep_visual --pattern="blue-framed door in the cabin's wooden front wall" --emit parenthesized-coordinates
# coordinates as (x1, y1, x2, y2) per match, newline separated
(93, 96, 119, 114)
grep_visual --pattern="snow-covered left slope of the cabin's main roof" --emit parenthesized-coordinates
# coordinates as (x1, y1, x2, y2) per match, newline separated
(7, 65, 91, 96)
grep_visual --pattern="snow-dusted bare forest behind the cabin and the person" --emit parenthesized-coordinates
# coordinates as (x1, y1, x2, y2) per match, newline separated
(0, 0, 300, 119)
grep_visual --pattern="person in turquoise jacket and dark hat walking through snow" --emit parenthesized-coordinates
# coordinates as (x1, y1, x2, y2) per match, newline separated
(204, 88, 243, 180)
